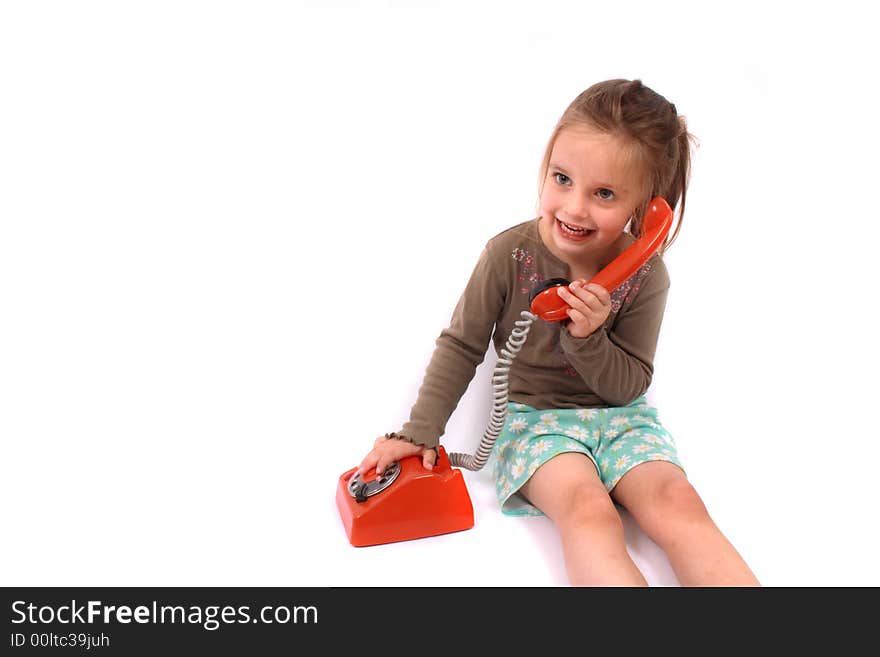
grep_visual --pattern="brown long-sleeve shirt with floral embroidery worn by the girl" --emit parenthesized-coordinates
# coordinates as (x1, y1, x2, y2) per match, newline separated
(400, 219, 669, 447)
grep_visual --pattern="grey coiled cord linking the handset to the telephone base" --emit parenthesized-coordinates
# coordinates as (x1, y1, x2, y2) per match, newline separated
(449, 310, 538, 470)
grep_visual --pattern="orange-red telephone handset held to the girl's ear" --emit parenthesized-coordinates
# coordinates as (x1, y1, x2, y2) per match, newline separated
(529, 196, 672, 322)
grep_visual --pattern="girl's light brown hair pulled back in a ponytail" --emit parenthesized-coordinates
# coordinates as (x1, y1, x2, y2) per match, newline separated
(539, 80, 694, 250)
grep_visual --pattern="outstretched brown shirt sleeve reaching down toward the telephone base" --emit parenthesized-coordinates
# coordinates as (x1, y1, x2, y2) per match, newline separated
(400, 246, 506, 448)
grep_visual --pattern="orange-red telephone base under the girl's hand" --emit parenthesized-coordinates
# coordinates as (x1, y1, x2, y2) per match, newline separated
(336, 446, 474, 547)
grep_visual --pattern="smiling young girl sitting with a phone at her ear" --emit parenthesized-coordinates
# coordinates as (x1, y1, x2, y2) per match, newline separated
(359, 80, 758, 586)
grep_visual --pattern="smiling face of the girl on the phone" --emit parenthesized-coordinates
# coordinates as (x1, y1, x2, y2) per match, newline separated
(540, 126, 644, 264)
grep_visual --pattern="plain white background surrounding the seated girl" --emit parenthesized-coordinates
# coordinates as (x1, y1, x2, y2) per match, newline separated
(0, 0, 880, 586)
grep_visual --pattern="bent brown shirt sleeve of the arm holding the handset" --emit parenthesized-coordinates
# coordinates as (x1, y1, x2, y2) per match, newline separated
(560, 259, 669, 406)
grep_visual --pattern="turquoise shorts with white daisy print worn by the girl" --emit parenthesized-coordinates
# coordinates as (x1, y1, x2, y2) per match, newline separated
(492, 397, 684, 516)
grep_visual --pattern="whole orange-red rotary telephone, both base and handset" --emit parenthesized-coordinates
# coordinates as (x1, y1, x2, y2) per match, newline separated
(336, 196, 673, 547)
